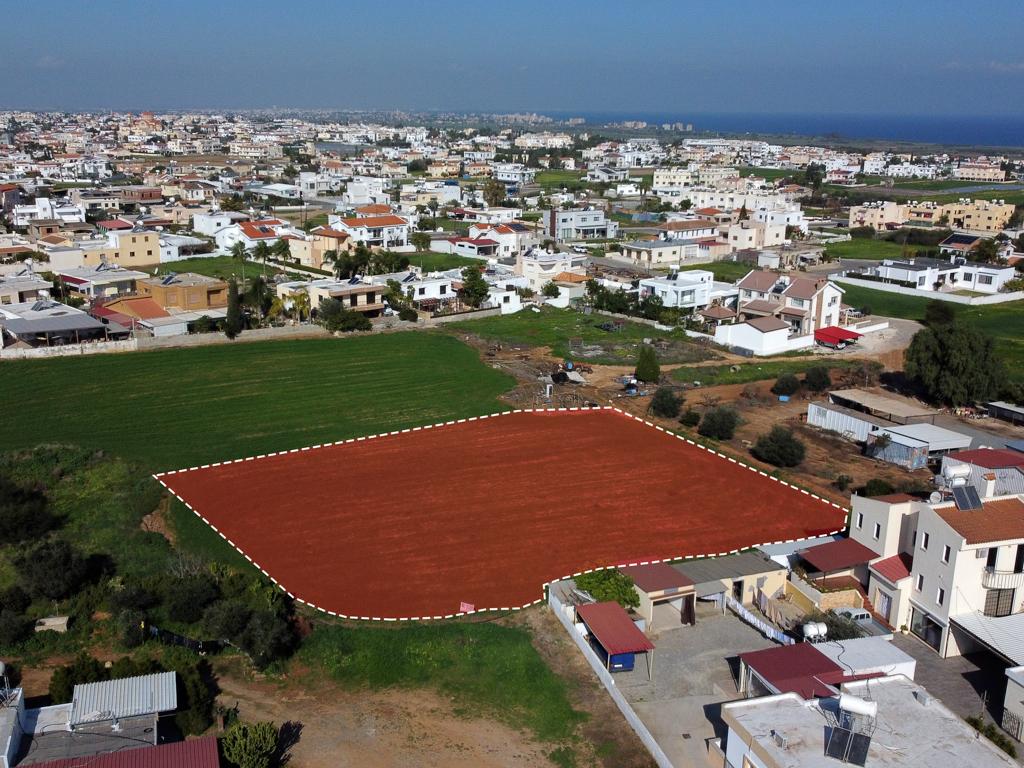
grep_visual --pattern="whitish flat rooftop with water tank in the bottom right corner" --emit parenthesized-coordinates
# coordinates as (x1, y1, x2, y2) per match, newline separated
(722, 676, 1017, 768)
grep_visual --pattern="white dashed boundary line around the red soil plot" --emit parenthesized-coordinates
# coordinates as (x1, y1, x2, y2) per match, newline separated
(153, 406, 849, 622)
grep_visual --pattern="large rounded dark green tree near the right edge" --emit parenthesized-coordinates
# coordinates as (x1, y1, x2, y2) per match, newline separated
(903, 322, 1007, 407)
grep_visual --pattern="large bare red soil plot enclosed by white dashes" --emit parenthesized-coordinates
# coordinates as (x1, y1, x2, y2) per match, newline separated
(160, 409, 845, 618)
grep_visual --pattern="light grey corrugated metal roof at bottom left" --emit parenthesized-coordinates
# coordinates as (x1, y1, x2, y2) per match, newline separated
(71, 672, 178, 727)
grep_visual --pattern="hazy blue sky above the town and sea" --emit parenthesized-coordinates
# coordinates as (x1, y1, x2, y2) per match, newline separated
(0, 0, 1024, 115)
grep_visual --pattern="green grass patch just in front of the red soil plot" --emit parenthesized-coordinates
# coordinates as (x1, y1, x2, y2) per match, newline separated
(298, 623, 585, 741)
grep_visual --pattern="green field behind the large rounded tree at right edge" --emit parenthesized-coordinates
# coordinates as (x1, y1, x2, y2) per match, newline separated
(840, 284, 1024, 381)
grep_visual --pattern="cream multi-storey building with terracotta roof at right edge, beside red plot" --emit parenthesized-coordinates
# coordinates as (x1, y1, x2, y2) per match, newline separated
(850, 489, 1024, 665)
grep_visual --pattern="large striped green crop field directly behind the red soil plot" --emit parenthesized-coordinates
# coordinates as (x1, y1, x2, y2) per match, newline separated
(0, 333, 514, 470)
